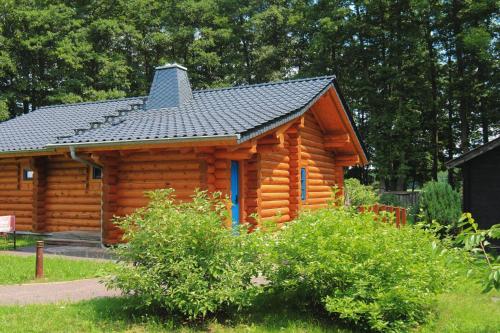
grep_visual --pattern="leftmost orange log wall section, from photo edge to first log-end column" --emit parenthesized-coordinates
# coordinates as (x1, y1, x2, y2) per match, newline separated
(0, 158, 33, 231)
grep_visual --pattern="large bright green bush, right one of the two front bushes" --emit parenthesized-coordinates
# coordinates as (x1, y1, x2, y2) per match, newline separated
(266, 209, 458, 332)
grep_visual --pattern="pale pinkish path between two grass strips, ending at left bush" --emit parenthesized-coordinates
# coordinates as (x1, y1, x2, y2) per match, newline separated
(0, 279, 121, 305)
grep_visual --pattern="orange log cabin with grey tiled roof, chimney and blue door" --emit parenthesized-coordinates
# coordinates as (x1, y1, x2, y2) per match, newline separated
(0, 64, 367, 244)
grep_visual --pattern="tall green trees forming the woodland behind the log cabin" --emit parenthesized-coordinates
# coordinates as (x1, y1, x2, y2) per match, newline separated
(0, 0, 500, 190)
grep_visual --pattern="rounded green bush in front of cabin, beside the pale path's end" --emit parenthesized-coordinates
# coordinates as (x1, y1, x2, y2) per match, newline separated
(108, 190, 259, 319)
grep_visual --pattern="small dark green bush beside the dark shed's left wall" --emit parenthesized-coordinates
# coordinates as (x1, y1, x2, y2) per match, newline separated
(420, 181, 462, 229)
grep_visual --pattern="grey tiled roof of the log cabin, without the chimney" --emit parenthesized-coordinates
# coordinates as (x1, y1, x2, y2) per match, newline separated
(0, 76, 342, 152)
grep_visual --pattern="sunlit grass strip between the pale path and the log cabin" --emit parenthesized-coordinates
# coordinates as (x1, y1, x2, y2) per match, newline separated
(0, 254, 113, 284)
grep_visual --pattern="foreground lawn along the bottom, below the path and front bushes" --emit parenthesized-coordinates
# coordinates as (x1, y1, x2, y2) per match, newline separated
(0, 282, 500, 333)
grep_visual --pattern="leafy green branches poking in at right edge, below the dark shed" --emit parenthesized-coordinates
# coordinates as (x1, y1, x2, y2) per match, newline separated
(455, 213, 500, 293)
